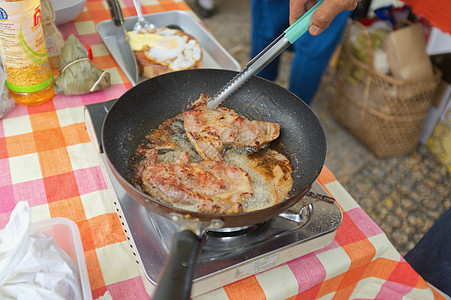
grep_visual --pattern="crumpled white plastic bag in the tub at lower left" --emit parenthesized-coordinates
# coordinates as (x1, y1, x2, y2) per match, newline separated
(0, 201, 82, 300)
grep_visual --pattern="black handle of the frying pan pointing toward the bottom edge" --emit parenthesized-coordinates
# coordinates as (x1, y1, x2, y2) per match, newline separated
(152, 230, 202, 300)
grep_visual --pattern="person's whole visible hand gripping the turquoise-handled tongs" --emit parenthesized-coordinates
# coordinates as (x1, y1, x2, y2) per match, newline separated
(290, 0, 360, 35)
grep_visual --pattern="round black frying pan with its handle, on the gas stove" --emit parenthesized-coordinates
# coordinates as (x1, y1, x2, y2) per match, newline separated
(102, 69, 327, 299)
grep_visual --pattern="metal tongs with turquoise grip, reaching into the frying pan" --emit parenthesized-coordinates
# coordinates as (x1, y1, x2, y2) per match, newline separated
(207, 0, 323, 109)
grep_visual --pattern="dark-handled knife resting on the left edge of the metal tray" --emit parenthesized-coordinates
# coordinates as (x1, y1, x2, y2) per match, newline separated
(108, 0, 138, 86)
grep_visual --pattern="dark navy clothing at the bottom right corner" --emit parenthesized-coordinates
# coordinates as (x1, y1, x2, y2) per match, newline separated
(404, 209, 451, 296)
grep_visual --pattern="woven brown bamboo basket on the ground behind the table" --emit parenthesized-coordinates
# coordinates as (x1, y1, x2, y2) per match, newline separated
(331, 22, 442, 157)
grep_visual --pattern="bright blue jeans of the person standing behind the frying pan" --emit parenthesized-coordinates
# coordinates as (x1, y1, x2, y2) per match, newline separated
(251, 0, 351, 104)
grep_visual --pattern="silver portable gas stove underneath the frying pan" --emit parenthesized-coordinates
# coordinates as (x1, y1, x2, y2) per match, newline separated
(85, 100, 342, 297)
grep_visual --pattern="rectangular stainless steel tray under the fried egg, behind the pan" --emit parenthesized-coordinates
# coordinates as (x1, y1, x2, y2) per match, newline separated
(96, 10, 241, 83)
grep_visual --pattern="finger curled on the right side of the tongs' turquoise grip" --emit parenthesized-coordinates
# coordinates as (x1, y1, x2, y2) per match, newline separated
(309, 0, 359, 35)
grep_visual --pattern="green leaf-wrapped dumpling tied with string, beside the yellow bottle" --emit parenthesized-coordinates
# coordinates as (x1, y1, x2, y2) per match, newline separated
(55, 34, 111, 95)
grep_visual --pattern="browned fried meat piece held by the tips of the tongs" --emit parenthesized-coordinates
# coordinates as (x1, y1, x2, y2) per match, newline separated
(183, 94, 280, 161)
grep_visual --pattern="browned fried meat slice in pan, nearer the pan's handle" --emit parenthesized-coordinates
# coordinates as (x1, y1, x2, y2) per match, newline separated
(139, 149, 253, 214)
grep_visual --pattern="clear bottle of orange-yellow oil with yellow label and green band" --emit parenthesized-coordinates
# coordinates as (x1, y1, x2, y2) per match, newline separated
(0, 0, 55, 105)
